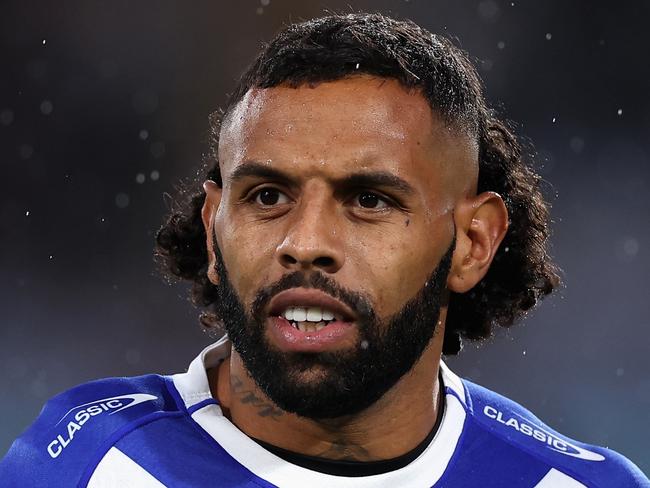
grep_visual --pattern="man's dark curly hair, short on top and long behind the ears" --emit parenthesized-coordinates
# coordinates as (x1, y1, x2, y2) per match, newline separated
(155, 13, 559, 354)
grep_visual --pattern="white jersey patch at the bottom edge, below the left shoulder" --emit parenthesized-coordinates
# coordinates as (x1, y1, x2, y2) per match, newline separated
(86, 447, 165, 488)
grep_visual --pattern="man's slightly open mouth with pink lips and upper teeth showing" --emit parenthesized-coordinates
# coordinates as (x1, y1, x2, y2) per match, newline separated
(268, 288, 357, 352)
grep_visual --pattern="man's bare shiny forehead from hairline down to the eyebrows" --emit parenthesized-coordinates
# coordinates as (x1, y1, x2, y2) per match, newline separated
(219, 75, 476, 192)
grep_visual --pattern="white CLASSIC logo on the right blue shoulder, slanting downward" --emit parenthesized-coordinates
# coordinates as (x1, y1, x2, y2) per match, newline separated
(483, 405, 605, 461)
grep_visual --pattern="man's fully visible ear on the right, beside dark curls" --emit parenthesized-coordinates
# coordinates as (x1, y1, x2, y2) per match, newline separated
(447, 192, 508, 293)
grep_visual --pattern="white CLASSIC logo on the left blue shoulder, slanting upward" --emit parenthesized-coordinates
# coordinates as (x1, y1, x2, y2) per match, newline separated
(47, 393, 158, 459)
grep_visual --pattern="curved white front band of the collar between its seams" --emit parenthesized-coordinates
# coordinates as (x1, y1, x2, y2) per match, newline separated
(192, 394, 465, 488)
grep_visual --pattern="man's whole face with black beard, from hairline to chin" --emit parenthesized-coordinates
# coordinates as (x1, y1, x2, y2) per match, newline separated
(211, 76, 476, 417)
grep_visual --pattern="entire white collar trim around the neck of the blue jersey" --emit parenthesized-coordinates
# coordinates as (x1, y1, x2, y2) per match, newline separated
(172, 337, 466, 488)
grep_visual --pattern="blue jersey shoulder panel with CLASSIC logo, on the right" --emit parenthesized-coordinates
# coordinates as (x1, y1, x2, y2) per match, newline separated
(462, 380, 650, 487)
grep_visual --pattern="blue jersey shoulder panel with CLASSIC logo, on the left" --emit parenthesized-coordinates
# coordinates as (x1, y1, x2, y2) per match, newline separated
(0, 375, 182, 486)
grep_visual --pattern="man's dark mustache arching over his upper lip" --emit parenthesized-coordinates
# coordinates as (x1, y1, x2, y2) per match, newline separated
(251, 271, 375, 322)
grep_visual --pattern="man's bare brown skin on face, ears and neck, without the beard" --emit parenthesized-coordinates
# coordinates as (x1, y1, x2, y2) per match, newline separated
(202, 75, 508, 461)
